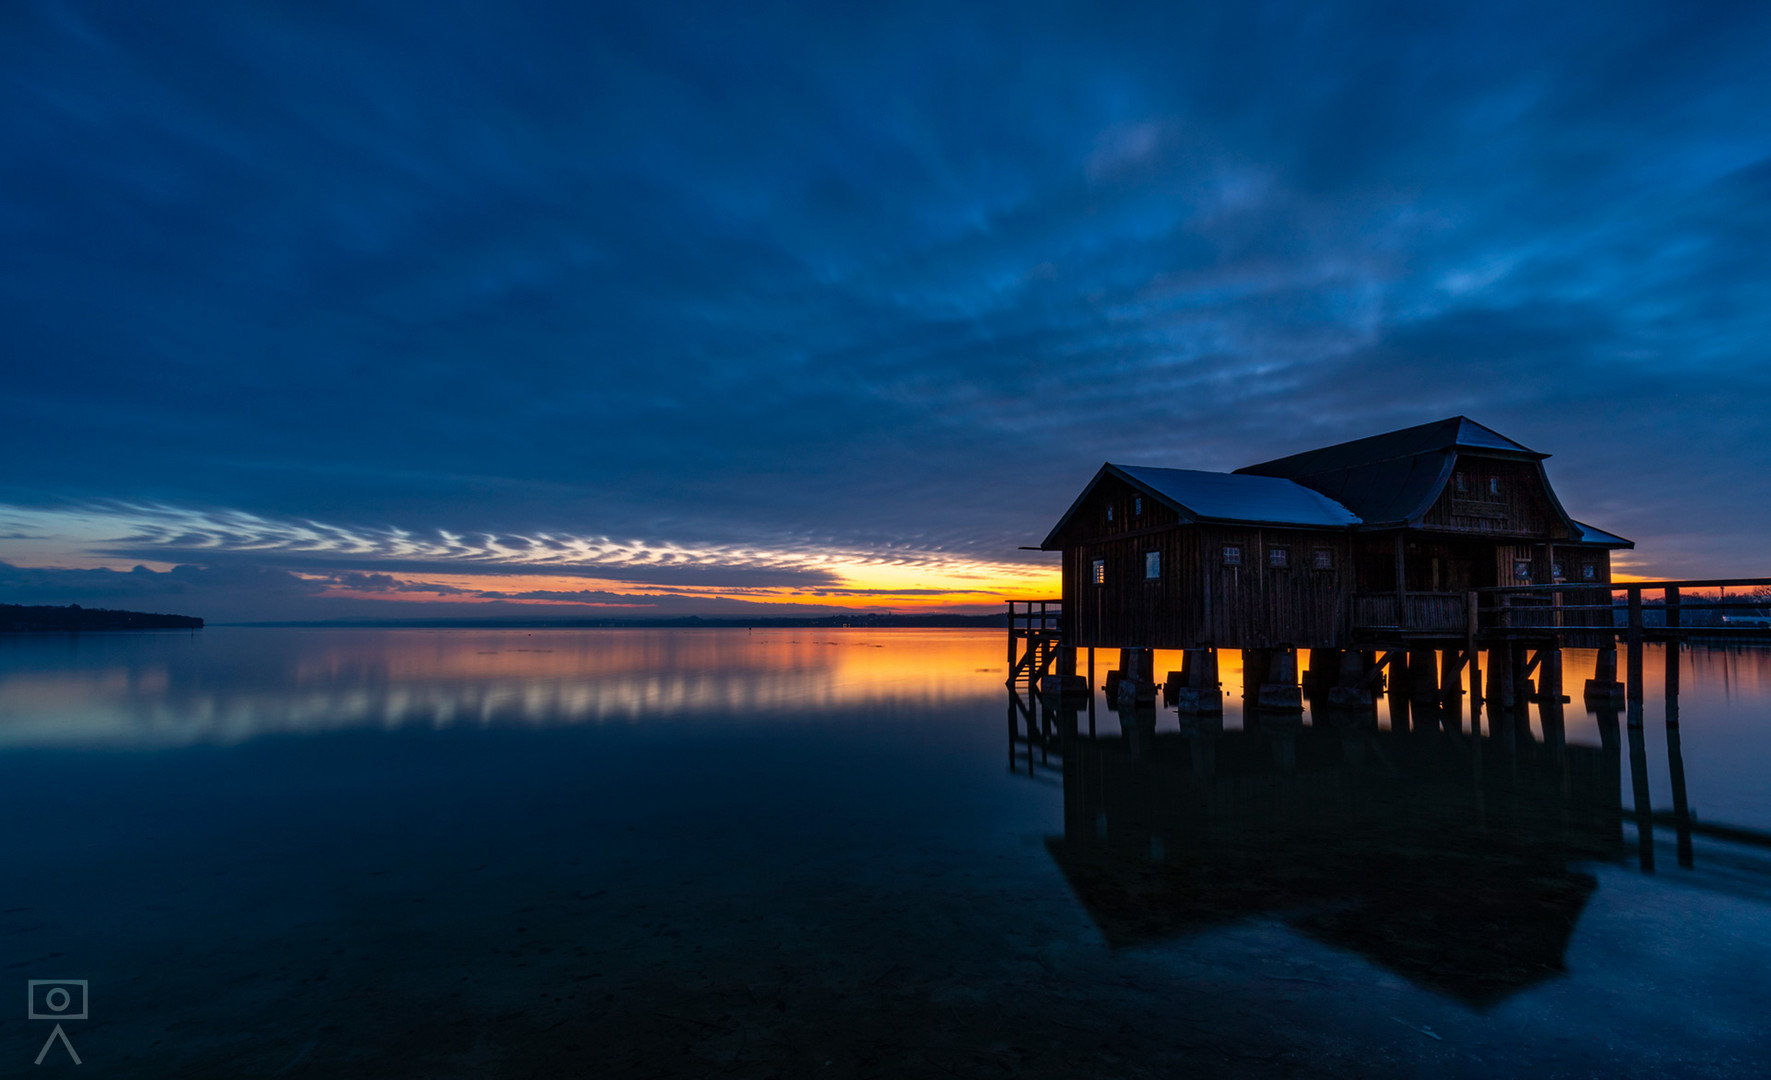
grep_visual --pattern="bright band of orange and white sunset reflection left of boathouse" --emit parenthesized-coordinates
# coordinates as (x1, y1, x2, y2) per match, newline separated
(0, 629, 1002, 747)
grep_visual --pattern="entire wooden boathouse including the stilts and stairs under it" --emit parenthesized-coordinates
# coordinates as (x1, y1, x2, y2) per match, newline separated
(1009, 416, 1640, 712)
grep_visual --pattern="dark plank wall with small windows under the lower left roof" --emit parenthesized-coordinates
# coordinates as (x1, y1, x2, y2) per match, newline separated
(1064, 524, 1353, 648)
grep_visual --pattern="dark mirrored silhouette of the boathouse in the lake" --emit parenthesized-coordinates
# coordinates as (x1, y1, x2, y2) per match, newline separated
(1020, 703, 1626, 1007)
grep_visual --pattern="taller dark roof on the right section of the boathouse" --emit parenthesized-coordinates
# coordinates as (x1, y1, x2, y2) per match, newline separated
(1236, 416, 1560, 526)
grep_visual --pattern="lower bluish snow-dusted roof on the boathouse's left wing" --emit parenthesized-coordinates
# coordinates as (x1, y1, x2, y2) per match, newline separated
(1040, 462, 1358, 551)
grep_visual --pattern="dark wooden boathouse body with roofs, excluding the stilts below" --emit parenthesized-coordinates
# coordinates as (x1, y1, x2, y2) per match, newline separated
(1040, 416, 1633, 650)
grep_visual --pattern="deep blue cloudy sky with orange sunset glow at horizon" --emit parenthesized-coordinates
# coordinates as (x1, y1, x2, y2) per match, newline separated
(0, 0, 1771, 621)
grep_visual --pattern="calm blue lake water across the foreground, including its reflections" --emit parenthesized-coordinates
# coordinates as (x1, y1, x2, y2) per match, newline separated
(0, 629, 1771, 1078)
